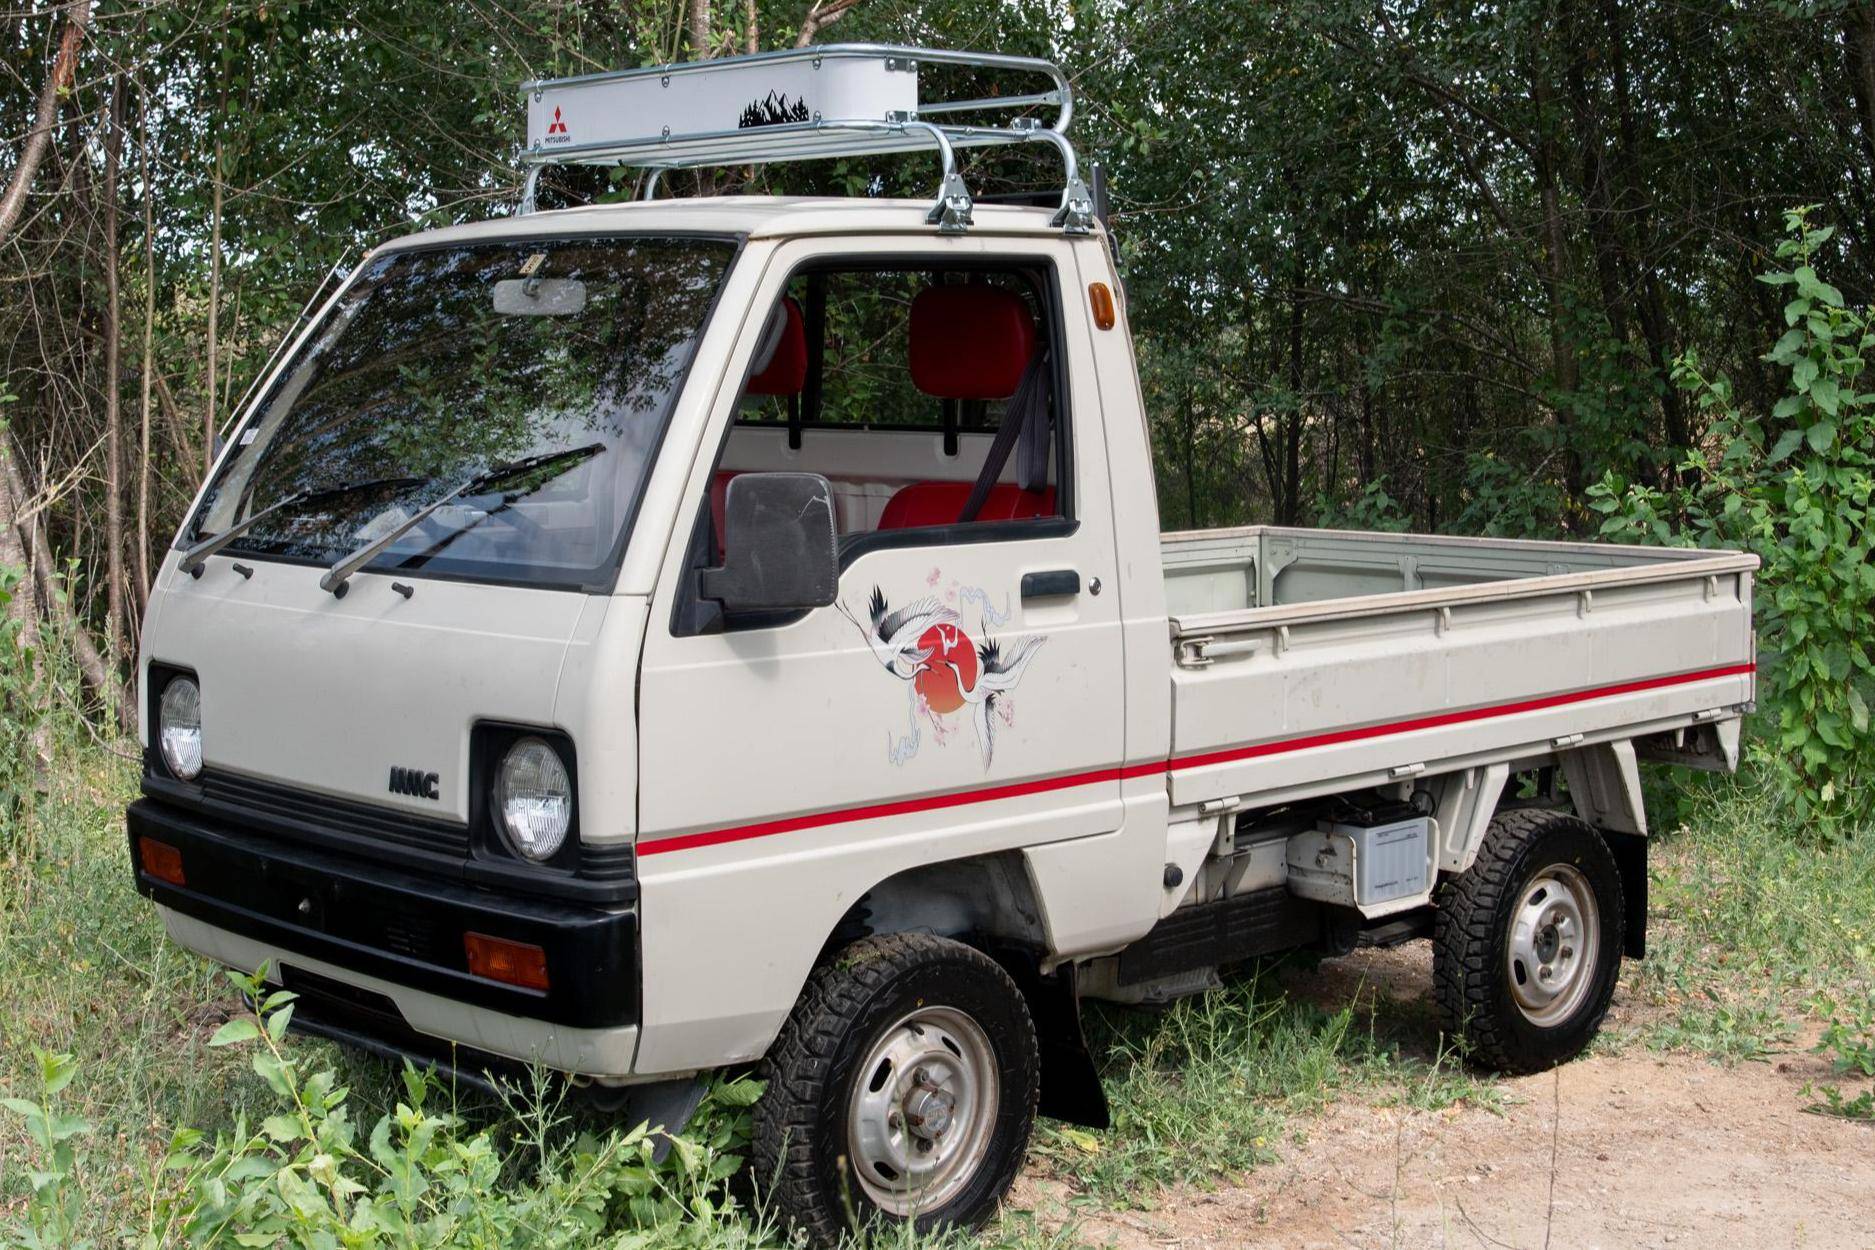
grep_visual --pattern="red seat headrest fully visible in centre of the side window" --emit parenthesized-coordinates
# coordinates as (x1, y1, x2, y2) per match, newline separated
(911, 285, 1035, 399)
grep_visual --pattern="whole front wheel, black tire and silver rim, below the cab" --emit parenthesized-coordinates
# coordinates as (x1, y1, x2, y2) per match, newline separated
(754, 933, 1039, 1244)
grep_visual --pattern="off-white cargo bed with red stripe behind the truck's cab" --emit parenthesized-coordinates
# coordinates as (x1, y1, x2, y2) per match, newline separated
(1161, 527, 1759, 806)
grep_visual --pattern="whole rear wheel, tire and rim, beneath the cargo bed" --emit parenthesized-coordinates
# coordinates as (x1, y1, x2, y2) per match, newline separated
(1433, 808, 1626, 1074)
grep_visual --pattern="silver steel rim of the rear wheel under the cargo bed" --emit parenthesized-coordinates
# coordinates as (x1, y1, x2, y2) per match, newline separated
(1504, 864, 1601, 1027)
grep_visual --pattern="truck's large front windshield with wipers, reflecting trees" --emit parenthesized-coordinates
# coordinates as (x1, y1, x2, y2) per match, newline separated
(184, 238, 735, 588)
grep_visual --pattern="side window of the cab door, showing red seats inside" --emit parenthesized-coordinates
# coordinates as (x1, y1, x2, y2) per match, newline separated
(677, 262, 1073, 632)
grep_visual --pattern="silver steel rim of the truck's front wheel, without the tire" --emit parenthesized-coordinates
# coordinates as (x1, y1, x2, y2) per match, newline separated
(846, 1006, 1001, 1216)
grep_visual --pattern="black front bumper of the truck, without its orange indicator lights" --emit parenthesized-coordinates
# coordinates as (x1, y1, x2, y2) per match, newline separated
(126, 798, 638, 1029)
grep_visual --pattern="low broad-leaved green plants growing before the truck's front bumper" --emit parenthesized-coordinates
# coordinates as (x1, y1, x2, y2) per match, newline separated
(0, 975, 774, 1250)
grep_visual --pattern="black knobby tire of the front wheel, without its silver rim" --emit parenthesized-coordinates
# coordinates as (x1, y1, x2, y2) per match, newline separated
(752, 933, 1041, 1246)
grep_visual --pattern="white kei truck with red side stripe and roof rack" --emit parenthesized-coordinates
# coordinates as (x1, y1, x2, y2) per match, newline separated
(128, 45, 1757, 1243)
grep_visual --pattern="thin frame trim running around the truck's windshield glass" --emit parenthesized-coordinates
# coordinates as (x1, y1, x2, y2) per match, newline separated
(171, 229, 748, 594)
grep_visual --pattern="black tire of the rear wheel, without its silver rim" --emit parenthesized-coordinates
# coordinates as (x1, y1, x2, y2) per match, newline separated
(1433, 808, 1626, 1074)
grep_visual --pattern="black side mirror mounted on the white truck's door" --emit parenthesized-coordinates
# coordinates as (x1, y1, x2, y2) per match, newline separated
(698, 472, 840, 613)
